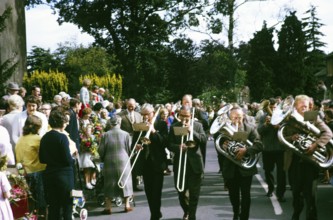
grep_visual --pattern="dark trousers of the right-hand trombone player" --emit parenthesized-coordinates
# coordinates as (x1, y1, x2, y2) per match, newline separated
(174, 165, 203, 220)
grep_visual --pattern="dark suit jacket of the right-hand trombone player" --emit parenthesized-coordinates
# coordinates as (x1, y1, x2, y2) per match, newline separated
(168, 119, 207, 173)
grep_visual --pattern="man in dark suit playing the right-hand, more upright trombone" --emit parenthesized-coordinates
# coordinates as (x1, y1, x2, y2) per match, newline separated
(169, 105, 207, 220)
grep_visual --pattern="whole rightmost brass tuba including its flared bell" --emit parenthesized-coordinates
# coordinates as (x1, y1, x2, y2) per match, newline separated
(272, 96, 333, 168)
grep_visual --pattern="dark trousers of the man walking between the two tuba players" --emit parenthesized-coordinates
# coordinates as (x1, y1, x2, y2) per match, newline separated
(262, 151, 286, 197)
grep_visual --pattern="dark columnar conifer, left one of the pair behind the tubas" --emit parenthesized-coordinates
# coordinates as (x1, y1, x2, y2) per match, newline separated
(247, 22, 276, 101)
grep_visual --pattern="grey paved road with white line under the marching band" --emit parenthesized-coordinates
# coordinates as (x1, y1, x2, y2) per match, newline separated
(78, 141, 333, 220)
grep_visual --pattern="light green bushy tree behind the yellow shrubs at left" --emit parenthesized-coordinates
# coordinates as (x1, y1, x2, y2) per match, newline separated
(27, 42, 119, 92)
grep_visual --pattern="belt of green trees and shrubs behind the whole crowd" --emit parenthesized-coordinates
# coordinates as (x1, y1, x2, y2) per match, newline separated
(22, 0, 332, 103)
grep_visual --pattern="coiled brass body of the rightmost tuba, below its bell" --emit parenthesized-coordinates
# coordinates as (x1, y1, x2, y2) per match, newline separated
(278, 111, 333, 168)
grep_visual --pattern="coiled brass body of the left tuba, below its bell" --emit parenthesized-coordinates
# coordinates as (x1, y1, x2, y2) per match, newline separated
(215, 118, 259, 169)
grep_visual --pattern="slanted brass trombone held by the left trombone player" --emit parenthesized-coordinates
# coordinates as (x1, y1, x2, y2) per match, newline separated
(118, 108, 160, 189)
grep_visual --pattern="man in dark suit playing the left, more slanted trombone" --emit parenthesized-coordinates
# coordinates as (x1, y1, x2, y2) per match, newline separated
(133, 104, 168, 220)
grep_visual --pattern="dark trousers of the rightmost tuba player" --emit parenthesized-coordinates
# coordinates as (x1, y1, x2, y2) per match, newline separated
(289, 155, 319, 220)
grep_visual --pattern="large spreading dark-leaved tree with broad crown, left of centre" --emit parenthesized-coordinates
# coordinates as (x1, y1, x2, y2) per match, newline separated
(26, 0, 207, 96)
